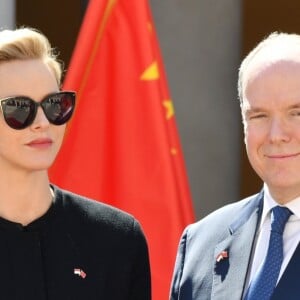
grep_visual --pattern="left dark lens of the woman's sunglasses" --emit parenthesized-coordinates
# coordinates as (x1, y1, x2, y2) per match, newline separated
(1, 97, 35, 129)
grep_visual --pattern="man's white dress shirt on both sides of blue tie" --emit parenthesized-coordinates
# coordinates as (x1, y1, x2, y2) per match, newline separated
(247, 185, 300, 286)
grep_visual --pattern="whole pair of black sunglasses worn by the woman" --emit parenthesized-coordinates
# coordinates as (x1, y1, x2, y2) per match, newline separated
(0, 91, 76, 129)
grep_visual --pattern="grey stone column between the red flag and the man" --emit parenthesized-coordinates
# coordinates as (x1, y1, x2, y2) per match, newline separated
(150, 0, 242, 219)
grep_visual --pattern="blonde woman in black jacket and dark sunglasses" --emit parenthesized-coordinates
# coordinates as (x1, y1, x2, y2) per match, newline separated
(0, 28, 150, 300)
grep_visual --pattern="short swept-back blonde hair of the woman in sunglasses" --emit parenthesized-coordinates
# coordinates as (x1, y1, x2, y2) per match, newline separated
(0, 28, 63, 85)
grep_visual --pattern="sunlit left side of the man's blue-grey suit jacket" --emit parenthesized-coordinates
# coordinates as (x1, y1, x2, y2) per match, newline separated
(171, 195, 263, 300)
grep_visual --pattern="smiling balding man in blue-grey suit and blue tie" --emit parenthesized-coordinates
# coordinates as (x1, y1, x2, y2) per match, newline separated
(170, 33, 300, 300)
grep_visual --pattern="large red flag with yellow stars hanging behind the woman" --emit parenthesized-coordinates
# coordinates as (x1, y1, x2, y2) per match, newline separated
(50, 0, 194, 300)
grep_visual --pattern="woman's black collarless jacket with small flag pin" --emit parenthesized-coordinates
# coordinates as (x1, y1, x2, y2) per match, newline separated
(0, 187, 151, 300)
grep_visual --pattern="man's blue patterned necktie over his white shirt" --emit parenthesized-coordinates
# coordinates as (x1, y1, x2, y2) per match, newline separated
(245, 206, 292, 300)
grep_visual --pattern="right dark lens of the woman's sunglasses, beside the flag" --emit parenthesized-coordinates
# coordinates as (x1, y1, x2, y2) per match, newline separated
(42, 92, 75, 125)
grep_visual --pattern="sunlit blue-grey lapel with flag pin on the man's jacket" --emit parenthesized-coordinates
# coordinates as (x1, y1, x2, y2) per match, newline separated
(211, 193, 263, 300)
